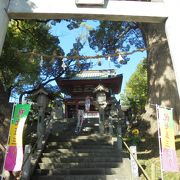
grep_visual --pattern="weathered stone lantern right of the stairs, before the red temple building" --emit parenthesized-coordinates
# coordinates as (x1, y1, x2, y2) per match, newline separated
(93, 85, 109, 133)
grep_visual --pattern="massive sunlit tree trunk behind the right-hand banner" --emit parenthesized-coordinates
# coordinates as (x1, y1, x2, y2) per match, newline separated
(142, 24, 180, 134)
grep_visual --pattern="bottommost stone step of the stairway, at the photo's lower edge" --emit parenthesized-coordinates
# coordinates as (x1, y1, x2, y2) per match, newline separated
(31, 175, 132, 180)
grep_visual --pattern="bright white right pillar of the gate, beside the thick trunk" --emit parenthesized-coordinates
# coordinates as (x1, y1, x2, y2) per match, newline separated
(164, 0, 180, 97)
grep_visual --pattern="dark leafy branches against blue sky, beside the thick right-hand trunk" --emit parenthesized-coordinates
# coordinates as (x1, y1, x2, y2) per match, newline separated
(88, 21, 145, 67)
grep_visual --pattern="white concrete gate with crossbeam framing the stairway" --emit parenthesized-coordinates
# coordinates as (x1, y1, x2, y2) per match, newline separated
(0, 0, 180, 132)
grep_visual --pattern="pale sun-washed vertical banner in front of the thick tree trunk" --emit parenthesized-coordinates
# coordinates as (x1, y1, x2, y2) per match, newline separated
(157, 106, 179, 172)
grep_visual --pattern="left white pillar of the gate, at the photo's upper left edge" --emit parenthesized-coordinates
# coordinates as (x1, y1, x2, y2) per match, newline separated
(0, 0, 9, 55)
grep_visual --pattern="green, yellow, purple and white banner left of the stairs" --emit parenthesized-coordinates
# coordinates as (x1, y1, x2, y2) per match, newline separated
(4, 104, 30, 171)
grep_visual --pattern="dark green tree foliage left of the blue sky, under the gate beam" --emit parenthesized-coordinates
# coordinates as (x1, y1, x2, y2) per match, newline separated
(0, 20, 88, 102)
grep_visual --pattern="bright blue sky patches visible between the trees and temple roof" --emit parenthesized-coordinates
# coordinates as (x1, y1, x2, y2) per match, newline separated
(51, 21, 146, 99)
